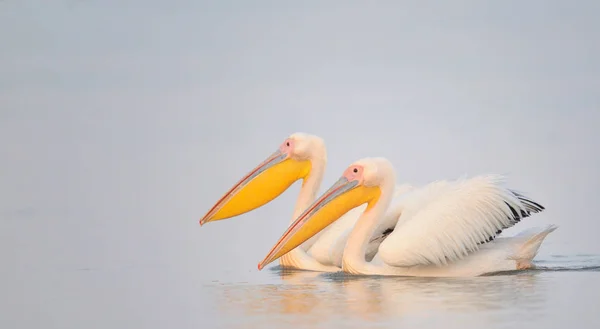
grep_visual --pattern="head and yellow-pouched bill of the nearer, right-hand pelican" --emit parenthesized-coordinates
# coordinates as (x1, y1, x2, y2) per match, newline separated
(258, 158, 396, 270)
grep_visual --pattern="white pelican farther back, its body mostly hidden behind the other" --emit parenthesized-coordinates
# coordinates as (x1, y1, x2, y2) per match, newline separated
(200, 133, 412, 272)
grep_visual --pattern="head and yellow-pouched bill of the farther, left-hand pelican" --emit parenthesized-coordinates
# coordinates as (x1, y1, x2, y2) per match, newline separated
(200, 133, 327, 225)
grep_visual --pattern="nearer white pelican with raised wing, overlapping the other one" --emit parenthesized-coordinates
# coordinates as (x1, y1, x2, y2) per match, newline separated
(258, 158, 556, 277)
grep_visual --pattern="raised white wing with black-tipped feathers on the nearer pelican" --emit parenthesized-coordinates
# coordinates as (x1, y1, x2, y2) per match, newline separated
(378, 176, 544, 266)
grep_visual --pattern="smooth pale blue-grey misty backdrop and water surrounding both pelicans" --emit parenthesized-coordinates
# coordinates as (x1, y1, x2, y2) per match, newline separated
(0, 0, 600, 329)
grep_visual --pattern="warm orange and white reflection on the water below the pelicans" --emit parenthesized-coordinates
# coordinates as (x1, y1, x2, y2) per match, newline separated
(211, 270, 547, 328)
